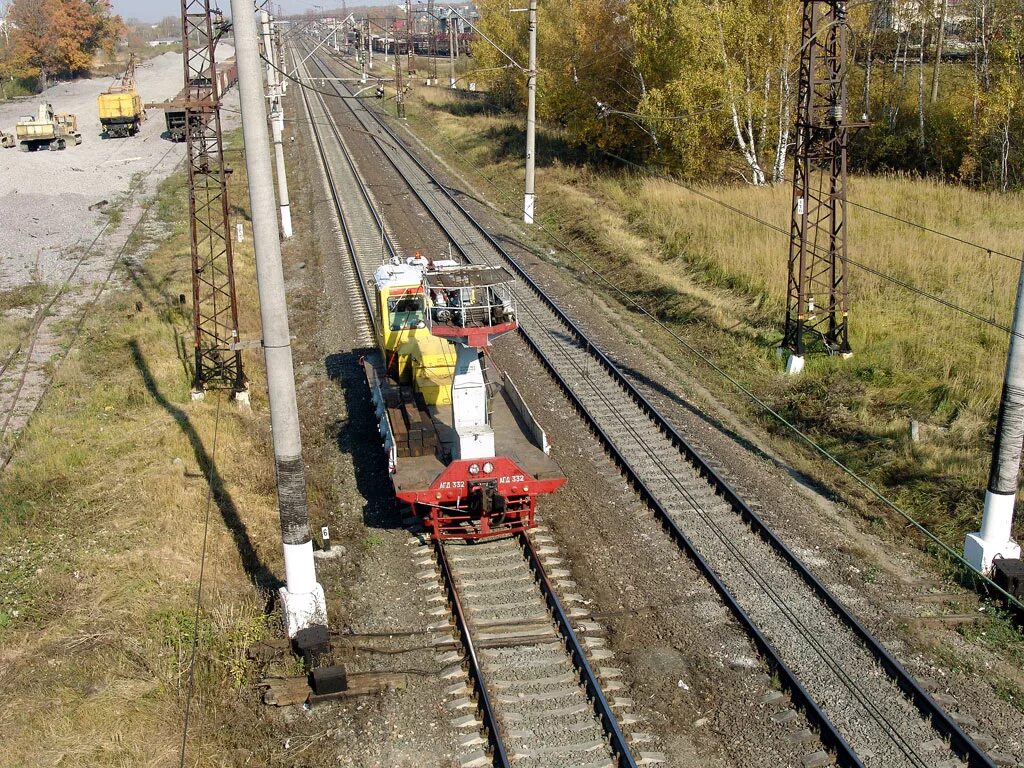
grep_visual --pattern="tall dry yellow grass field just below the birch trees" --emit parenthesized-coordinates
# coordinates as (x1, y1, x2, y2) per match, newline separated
(606, 177, 1024, 409)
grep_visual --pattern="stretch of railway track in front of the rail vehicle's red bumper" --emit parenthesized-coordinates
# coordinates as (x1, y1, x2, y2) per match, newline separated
(435, 536, 630, 768)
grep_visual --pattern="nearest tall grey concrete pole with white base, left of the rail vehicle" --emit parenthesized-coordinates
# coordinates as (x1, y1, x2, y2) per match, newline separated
(231, 0, 329, 655)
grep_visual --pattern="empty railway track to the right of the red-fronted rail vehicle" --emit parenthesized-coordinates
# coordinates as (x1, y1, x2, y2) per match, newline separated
(294, 37, 993, 768)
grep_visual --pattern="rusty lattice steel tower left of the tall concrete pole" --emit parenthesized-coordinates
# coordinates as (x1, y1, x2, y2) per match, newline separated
(181, 0, 246, 394)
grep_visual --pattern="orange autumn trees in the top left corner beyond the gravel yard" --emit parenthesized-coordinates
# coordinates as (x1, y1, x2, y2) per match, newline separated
(0, 0, 125, 97)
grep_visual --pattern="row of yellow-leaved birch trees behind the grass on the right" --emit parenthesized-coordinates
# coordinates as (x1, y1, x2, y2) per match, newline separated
(474, 0, 1024, 189)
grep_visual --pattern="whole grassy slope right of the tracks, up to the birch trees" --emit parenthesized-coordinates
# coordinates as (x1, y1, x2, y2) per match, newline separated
(393, 89, 1024, 561)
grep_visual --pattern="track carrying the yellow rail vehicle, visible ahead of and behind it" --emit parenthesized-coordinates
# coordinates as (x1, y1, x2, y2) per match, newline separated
(290, 49, 638, 768)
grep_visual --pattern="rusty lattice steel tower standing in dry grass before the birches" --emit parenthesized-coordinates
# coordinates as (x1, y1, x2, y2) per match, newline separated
(782, 0, 852, 371)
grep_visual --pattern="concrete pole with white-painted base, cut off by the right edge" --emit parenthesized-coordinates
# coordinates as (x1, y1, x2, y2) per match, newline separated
(964, 266, 1024, 575)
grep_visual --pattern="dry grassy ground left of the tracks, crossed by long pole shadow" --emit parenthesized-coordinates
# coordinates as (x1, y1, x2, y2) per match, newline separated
(0, 134, 296, 766)
